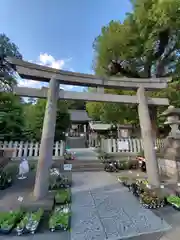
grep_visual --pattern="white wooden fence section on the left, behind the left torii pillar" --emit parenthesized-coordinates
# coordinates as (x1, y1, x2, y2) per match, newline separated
(0, 141, 65, 158)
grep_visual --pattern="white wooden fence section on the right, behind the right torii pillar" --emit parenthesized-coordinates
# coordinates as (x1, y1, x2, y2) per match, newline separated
(101, 138, 164, 153)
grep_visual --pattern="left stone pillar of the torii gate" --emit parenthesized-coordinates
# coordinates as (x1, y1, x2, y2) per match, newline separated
(33, 77, 59, 200)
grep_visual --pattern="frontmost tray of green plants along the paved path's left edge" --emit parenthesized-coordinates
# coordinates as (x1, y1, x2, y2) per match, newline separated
(49, 205, 71, 232)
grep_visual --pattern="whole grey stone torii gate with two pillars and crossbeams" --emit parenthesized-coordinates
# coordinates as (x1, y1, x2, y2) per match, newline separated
(7, 58, 170, 200)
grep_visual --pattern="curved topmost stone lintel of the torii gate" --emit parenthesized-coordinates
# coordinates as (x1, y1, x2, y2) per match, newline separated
(6, 57, 171, 90)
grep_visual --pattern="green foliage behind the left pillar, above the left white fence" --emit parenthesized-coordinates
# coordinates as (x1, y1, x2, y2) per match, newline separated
(0, 93, 70, 141)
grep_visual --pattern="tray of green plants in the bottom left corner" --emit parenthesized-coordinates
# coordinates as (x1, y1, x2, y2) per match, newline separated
(0, 210, 23, 234)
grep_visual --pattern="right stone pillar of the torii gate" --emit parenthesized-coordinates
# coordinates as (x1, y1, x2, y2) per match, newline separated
(137, 86, 160, 188)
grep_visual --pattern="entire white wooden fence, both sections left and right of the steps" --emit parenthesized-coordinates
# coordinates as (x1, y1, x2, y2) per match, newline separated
(0, 138, 164, 158)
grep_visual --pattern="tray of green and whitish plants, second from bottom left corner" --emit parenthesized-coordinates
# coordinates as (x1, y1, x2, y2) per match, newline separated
(16, 208, 44, 236)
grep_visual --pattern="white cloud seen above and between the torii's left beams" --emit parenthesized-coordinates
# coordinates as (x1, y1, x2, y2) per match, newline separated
(18, 53, 84, 91)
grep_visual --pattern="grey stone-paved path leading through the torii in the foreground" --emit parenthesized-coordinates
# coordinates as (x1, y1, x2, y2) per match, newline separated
(71, 172, 171, 240)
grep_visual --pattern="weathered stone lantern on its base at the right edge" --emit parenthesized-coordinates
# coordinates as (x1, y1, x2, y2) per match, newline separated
(162, 106, 180, 183)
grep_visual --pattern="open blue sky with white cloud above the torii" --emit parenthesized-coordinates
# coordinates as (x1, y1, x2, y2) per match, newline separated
(0, 0, 131, 90)
